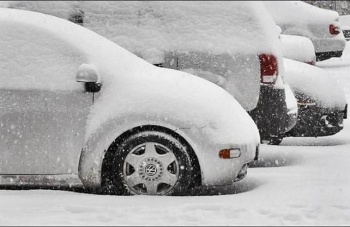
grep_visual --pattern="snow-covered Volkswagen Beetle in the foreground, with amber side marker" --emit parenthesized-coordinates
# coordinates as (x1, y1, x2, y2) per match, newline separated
(0, 8, 260, 195)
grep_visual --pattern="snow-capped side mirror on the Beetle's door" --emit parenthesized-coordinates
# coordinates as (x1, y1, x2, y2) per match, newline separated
(75, 64, 101, 92)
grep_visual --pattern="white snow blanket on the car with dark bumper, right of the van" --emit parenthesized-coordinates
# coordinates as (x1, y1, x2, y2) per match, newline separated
(284, 58, 346, 109)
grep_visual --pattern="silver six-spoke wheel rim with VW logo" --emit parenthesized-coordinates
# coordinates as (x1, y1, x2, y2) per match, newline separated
(123, 142, 179, 195)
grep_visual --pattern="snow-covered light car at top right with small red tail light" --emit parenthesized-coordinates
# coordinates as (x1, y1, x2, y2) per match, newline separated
(264, 1, 346, 61)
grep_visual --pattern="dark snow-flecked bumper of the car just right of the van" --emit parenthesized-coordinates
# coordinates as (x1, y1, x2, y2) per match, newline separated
(287, 105, 346, 137)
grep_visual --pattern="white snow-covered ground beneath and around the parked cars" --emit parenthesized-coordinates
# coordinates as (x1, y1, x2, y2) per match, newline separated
(0, 44, 350, 226)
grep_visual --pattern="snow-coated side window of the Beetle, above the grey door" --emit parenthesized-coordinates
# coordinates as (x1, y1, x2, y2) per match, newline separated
(0, 21, 86, 91)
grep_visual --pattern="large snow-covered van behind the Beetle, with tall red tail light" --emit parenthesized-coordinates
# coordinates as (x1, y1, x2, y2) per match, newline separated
(12, 1, 288, 143)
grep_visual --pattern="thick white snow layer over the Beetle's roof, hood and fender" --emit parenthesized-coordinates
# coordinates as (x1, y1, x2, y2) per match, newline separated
(0, 9, 259, 143)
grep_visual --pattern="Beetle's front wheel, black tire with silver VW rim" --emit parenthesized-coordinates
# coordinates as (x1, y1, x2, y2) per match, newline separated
(106, 131, 193, 195)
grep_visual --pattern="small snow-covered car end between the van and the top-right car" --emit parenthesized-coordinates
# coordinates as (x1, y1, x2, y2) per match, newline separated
(281, 35, 316, 63)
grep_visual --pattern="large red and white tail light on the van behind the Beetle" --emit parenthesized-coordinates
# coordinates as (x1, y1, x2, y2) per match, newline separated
(259, 54, 278, 84)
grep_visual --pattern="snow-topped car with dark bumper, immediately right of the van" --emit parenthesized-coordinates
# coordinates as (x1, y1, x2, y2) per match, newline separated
(284, 58, 347, 137)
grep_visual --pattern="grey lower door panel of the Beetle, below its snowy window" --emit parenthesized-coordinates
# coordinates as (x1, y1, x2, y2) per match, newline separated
(0, 90, 92, 174)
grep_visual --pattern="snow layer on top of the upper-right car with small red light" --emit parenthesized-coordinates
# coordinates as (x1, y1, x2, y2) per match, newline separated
(263, 1, 339, 25)
